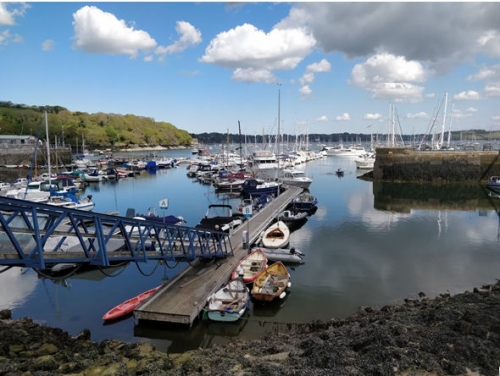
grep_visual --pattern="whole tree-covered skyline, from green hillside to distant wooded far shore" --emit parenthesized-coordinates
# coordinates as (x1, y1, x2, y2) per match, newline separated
(0, 101, 500, 148)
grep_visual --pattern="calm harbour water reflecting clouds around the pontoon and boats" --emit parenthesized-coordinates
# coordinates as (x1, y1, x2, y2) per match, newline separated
(0, 151, 500, 352)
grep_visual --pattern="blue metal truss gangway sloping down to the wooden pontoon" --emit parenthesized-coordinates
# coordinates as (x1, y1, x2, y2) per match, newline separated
(0, 197, 234, 269)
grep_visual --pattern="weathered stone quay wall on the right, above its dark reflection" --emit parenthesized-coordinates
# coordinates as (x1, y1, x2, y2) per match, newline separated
(373, 148, 500, 183)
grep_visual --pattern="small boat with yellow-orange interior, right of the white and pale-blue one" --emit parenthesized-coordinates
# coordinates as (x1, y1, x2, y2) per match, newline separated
(252, 261, 291, 302)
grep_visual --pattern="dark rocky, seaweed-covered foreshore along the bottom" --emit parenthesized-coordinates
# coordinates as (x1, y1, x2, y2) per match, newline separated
(0, 282, 500, 376)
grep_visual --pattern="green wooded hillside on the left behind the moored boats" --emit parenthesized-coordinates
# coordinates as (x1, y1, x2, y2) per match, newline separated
(0, 102, 192, 148)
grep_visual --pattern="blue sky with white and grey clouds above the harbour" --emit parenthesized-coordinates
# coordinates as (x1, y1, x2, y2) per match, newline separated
(0, 2, 500, 134)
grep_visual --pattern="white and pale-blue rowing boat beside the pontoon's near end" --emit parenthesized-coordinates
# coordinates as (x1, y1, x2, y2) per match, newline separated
(206, 279, 250, 322)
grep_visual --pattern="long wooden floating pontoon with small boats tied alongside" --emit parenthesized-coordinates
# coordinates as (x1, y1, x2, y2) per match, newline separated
(134, 187, 302, 325)
